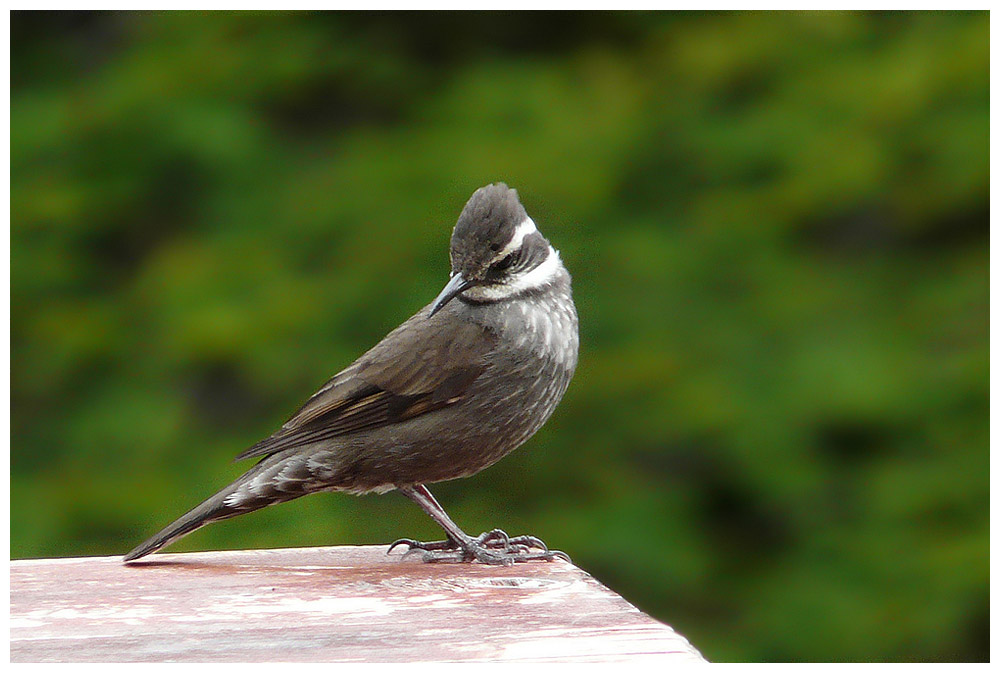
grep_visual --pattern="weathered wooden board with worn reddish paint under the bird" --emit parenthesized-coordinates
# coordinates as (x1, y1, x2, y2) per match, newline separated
(10, 547, 701, 662)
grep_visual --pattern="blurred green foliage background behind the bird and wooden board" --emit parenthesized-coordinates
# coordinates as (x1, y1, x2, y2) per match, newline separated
(11, 12, 989, 661)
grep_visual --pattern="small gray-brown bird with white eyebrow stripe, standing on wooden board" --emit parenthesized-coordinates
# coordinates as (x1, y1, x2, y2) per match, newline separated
(124, 183, 579, 565)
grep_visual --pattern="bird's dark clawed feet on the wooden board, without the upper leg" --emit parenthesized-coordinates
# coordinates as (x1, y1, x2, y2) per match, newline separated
(386, 528, 570, 565)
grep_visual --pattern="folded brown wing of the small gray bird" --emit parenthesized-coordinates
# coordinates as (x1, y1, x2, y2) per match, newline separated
(236, 311, 496, 460)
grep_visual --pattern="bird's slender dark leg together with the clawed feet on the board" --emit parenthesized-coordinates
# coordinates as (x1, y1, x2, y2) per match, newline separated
(389, 484, 569, 565)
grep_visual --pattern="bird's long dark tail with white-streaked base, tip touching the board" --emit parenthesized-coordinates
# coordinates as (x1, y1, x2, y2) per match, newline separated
(122, 456, 305, 563)
